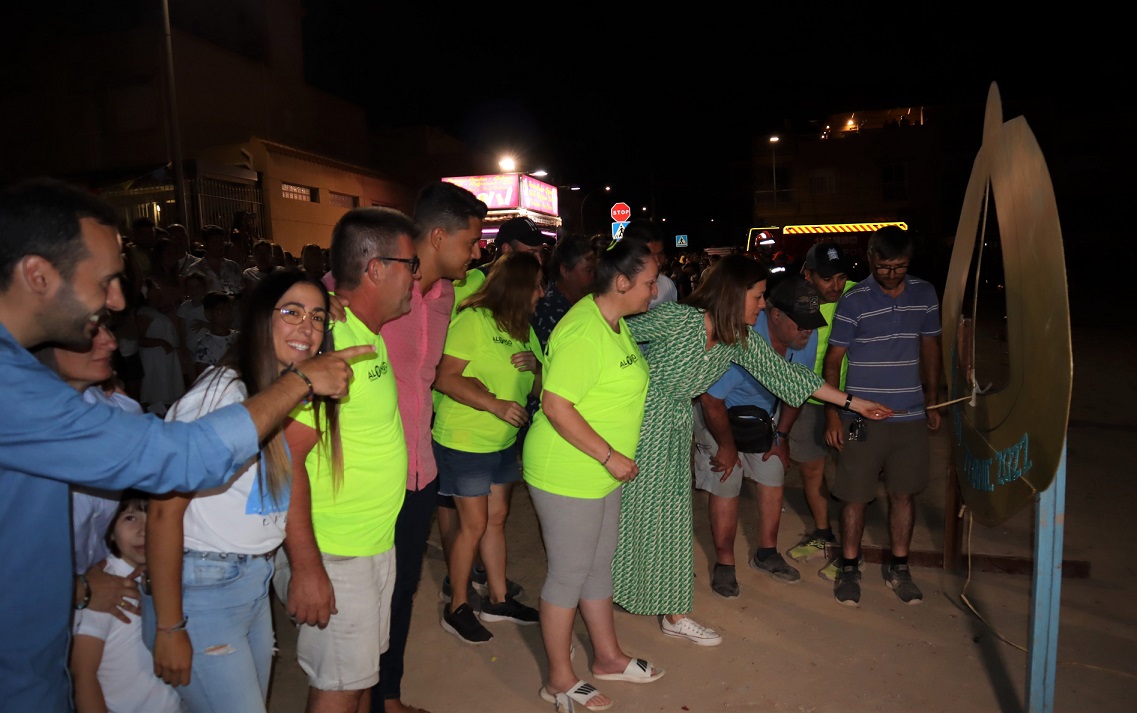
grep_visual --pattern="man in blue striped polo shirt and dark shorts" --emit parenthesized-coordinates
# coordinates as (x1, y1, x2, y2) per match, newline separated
(824, 225, 943, 606)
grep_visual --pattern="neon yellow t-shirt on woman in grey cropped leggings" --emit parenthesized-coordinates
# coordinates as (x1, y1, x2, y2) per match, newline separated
(522, 295, 648, 499)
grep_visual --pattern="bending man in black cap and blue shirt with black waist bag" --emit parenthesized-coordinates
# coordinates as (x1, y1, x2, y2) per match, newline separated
(695, 275, 827, 598)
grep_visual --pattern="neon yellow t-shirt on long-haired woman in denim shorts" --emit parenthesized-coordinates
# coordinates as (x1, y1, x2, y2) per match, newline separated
(431, 307, 545, 453)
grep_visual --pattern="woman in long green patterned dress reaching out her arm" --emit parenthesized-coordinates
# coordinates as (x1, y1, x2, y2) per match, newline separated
(613, 255, 891, 646)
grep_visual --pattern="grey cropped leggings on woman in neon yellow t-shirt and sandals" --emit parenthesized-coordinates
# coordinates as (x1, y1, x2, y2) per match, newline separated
(529, 486, 621, 610)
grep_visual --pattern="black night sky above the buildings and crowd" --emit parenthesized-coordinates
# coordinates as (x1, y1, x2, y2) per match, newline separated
(304, 0, 1131, 245)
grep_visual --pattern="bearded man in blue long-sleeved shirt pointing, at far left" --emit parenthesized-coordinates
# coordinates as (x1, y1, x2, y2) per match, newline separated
(0, 181, 363, 713)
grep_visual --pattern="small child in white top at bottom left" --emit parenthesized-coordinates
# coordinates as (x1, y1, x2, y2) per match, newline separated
(70, 490, 182, 713)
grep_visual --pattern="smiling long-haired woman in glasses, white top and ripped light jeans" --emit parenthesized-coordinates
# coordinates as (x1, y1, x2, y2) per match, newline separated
(143, 270, 341, 713)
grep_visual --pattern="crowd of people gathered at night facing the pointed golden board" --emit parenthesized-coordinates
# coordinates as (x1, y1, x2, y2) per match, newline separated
(0, 173, 940, 713)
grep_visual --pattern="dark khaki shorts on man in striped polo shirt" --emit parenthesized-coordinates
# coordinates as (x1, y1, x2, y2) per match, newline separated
(832, 418, 931, 503)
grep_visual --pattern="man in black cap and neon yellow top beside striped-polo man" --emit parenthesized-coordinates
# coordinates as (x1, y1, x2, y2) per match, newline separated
(786, 242, 856, 581)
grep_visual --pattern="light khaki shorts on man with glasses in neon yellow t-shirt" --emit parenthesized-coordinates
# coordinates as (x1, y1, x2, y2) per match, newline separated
(273, 547, 395, 690)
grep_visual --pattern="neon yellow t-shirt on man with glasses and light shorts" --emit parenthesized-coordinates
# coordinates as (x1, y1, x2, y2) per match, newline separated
(292, 308, 407, 557)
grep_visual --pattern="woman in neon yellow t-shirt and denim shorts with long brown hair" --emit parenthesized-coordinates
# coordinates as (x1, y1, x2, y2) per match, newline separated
(431, 251, 543, 644)
